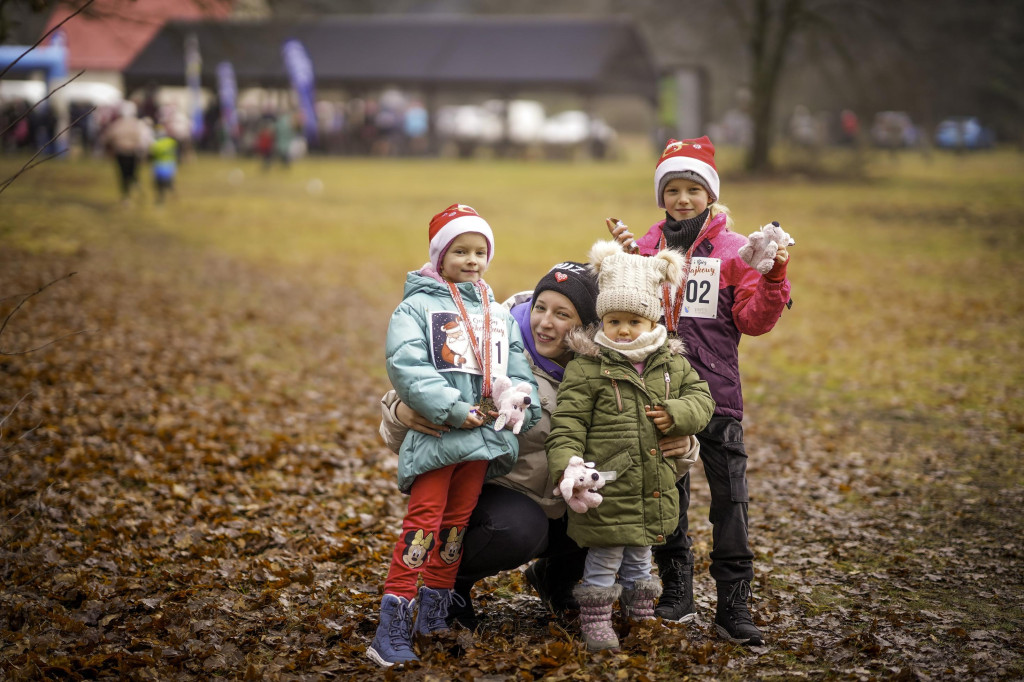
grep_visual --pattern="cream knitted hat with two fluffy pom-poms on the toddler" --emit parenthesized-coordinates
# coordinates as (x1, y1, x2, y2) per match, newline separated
(590, 242, 686, 322)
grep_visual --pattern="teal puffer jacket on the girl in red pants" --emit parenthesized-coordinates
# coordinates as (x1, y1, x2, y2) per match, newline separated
(385, 268, 541, 493)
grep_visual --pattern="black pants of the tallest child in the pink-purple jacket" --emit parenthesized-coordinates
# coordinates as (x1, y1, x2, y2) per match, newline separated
(654, 417, 754, 583)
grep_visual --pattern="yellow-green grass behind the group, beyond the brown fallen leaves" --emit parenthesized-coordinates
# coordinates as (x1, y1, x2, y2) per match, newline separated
(0, 142, 1024, 448)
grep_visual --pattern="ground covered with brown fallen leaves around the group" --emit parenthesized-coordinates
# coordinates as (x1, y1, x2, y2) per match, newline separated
(0, 151, 1024, 680)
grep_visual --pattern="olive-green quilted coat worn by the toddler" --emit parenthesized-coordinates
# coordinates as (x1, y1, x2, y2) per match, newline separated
(546, 333, 715, 547)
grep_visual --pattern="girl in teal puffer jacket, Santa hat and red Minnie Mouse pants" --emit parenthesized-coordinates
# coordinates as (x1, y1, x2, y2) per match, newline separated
(367, 204, 540, 666)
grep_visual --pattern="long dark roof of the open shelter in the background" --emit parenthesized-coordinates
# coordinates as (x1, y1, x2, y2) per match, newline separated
(123, 16, 657, 100)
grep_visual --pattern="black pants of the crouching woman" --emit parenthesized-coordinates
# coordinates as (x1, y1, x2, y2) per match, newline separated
(456, 484, 587, 594)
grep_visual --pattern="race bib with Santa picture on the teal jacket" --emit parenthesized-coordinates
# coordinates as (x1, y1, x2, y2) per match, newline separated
(430, 309, 509, 377)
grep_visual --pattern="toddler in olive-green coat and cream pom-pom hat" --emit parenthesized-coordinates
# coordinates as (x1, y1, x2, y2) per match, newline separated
(546, 242, 715, 650)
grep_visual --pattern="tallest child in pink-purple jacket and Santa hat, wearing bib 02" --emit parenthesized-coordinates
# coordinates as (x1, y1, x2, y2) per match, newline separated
(608, 136, 790, 644)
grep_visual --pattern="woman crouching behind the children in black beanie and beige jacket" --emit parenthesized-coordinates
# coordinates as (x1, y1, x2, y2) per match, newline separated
(381, 261, 696, 629)
